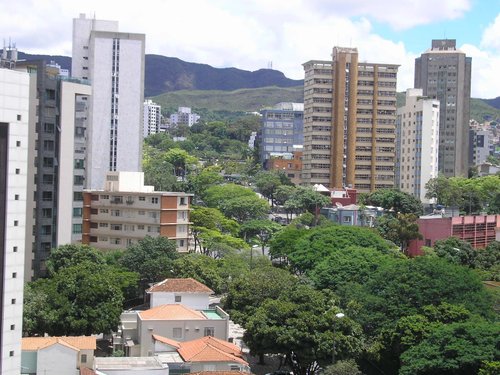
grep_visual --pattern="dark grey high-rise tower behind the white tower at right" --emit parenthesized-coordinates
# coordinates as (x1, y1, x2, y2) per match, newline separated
(415, 39, 472, 177)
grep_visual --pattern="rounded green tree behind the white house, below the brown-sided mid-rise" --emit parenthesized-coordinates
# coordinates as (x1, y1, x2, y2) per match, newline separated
(120, 236, 178, 283)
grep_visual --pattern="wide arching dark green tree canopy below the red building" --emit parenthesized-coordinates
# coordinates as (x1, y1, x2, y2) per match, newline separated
(339, 257, 493, 332)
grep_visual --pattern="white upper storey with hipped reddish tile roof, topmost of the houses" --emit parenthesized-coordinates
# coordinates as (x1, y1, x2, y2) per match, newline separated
(147, 278, 214, 310)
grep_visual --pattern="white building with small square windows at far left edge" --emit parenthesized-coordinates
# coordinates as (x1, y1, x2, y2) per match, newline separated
(0, 68, 30, 375)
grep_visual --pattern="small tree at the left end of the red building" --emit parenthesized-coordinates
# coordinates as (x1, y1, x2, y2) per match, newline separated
(375, 213, 422, 253)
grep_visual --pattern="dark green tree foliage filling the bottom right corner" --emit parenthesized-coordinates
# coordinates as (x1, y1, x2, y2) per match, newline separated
(400, 322, 500, 375)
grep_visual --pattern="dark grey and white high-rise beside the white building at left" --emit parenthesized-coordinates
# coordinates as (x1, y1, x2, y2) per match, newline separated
(16, 60, 90, 281)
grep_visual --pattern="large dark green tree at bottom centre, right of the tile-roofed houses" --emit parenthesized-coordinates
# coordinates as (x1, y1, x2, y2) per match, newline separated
(243, 284, 362, 375)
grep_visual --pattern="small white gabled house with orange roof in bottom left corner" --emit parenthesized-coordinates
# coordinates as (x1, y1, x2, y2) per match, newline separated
(21, 336, 96, 375)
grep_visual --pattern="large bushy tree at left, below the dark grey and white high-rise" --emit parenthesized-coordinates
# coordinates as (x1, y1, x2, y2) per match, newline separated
(24, 261, 124, 336)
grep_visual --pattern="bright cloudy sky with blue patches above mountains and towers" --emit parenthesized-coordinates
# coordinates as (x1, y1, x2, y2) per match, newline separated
(0, 0, 500, 98)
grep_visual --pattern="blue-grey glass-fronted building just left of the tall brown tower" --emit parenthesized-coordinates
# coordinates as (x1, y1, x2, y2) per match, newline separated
(259, 102, 304, 167)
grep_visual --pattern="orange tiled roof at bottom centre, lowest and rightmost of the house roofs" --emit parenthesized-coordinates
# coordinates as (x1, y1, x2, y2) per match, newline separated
(177, 336, 248, 366)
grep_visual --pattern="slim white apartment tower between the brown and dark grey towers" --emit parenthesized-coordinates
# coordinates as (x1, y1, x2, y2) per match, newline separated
(396, 89, 439, 203)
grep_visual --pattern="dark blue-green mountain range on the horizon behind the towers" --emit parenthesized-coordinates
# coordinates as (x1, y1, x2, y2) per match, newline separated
(9, 52, 500, 118)
